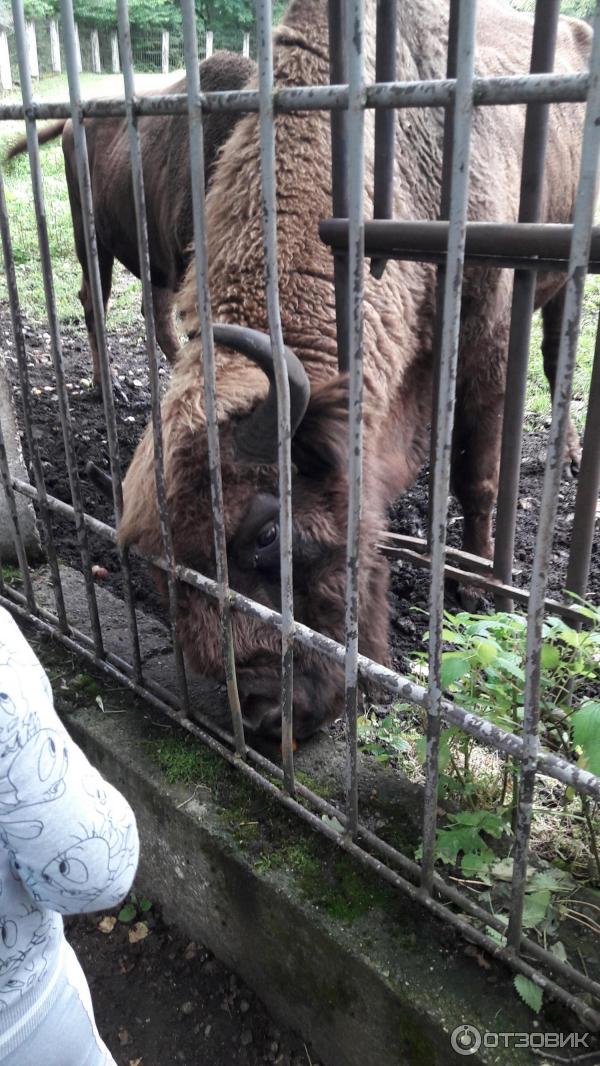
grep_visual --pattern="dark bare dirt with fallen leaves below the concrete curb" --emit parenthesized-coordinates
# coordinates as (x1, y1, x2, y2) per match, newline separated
(66, 909, 319, 1066)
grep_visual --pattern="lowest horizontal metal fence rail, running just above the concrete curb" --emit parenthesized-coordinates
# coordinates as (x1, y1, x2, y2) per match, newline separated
(0, 589, 600, 1030)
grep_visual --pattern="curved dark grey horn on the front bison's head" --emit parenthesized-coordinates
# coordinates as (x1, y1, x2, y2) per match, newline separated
(213, 325, 310, 463)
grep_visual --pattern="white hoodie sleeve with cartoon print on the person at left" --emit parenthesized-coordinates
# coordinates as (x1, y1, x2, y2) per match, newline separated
(0, 609, 140, 915)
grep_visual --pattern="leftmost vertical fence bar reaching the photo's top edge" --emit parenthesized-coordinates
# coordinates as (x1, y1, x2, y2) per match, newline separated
(13, 0, 104, 659)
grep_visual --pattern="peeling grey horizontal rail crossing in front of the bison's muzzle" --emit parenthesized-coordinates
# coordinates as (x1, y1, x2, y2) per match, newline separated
(13, 478, 600, 801)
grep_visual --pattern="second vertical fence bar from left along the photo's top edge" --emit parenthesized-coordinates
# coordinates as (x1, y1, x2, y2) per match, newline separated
(61, 0, 142, 684)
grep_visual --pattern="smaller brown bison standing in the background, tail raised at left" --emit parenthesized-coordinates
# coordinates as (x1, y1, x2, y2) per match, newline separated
(5, 51, 256, 388)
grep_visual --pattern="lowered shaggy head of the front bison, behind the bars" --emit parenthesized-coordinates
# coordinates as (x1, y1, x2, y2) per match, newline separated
(119, 326, 388, 739)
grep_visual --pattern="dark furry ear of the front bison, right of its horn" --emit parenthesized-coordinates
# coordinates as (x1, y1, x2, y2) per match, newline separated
(292, 374, 348, 479)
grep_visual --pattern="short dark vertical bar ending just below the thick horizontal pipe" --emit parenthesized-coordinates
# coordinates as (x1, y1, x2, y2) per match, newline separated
(371, 0, 396, 278)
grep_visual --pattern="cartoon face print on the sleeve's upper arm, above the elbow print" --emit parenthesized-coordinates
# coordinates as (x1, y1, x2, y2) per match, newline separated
(0, 729, 68, 817)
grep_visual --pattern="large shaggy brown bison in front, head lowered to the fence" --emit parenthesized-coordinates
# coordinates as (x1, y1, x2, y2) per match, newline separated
(119, 0, 590, 738)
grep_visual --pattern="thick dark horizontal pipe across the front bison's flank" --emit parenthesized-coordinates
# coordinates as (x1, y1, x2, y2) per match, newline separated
(319, 219, 600, 273)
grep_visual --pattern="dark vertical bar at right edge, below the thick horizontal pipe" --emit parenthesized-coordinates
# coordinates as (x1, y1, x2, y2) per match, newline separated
(565, 318, 600, 597)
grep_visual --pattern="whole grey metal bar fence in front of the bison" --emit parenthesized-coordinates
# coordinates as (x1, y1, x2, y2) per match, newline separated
(0, 0, 600, 1028)
